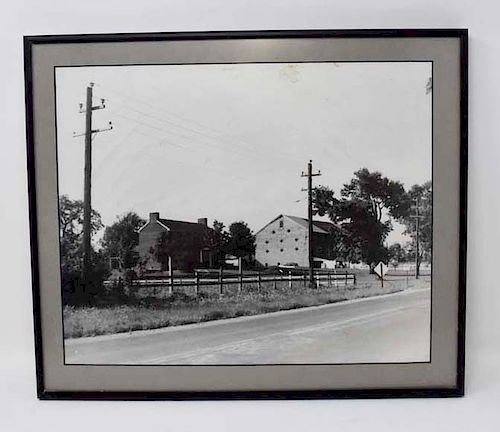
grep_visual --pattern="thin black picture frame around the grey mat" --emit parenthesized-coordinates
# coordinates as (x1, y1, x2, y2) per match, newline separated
(24, 29, 468, 400)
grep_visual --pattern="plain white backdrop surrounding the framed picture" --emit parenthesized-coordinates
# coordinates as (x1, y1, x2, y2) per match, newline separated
(0, 0, 500, 432)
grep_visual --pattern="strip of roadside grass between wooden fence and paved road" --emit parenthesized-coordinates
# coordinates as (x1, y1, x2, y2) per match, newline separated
(63, 275, 430, 338)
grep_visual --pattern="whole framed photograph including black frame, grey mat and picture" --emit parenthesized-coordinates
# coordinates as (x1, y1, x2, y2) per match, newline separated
(24, 29, 467, 400)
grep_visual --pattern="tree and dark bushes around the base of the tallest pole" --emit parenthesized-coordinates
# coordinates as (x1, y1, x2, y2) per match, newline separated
(59, 195, 106, 302)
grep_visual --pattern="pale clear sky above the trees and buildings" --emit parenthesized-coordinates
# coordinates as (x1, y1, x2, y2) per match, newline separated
(56, 62, 432, 244)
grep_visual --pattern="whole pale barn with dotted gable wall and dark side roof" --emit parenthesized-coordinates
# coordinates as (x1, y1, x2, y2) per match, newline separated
(255, 215, 338, 267)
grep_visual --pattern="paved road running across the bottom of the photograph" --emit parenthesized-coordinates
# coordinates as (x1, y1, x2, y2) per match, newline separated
(65, 289, 430, 365)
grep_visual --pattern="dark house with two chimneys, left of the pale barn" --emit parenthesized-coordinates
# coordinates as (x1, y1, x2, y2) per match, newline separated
(137, 212, 212, 272)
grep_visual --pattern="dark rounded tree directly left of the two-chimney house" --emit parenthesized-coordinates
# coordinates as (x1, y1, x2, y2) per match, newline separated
(101, 212, 146, 270)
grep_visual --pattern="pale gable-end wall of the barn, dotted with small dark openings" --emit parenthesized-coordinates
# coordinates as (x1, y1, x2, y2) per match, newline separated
(255, 216, 309, 266)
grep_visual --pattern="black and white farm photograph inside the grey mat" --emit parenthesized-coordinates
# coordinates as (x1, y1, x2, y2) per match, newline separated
(55, 61, 433, 365)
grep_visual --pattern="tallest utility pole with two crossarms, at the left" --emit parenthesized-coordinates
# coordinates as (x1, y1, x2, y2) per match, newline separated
(73, 83, 113, 287)
